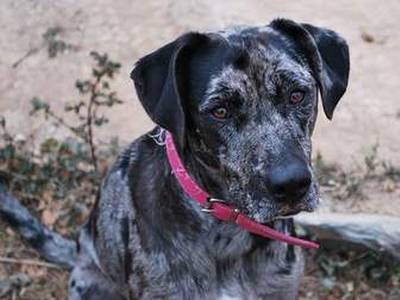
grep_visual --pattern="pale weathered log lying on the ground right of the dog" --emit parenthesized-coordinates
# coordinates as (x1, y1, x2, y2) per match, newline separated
(295, 213, 400, 261)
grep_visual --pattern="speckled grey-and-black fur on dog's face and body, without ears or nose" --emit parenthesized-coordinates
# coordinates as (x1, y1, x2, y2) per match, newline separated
(70, 18, 348, 300)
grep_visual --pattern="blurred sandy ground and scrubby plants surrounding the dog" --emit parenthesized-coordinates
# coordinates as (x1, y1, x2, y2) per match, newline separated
(0, 0, 400, 299)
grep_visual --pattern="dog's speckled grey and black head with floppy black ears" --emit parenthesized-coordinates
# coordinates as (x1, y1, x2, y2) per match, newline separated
(132, 19, 349, 223)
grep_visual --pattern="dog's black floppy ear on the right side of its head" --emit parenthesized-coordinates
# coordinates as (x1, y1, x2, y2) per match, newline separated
(271, 19, 350, 119)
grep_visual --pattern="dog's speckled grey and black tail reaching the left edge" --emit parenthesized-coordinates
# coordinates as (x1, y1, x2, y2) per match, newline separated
(0, 181, 76, 270)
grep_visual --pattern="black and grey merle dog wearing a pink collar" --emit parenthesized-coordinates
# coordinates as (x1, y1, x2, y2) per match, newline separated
(69, 19, 349, 299)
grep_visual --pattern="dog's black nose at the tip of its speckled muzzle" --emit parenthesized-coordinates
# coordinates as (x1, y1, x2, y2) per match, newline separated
(269, 160, 311, 202)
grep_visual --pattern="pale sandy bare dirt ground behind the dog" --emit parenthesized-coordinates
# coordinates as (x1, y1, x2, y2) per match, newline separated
(0, 0, 400, 299)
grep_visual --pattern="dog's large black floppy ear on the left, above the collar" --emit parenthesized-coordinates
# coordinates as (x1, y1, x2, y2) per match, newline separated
(131, 33, 207, 146)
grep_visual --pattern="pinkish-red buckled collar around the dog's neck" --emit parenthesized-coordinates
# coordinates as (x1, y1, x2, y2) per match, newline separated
(165, 131, 319, 249)
